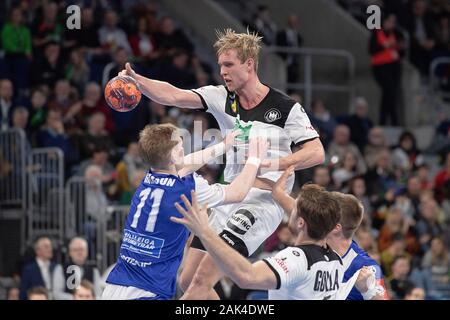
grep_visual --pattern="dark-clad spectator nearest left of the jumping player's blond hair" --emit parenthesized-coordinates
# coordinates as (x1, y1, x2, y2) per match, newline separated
(155, 17, 194, 56)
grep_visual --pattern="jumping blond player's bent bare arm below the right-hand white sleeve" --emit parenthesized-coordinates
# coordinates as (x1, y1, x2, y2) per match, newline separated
(278, 138, 325, 170)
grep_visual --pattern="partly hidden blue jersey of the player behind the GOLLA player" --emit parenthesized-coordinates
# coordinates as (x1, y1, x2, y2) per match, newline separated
(342, 240, 386, 300)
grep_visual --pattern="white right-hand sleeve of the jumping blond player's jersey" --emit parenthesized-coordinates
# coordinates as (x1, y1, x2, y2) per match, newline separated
(284, 103, 319, 143)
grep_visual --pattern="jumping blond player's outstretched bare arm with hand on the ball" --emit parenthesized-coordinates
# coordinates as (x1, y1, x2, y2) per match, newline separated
(119, 63, 203, 109)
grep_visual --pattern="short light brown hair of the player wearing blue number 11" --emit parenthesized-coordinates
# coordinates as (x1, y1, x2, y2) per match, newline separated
(139, 123, 178, 169)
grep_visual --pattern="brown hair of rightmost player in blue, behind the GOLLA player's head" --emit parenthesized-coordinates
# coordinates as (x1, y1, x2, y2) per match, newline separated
(331, 191, 364, 239)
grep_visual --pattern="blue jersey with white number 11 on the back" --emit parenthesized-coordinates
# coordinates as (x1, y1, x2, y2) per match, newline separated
(106, 171, 224, 299)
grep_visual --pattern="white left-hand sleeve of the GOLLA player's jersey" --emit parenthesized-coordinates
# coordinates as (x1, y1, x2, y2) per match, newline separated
(263, 247, 308, 289)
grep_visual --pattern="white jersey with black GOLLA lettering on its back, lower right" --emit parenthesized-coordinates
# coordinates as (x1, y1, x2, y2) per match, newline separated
(263, 245, 345, 300)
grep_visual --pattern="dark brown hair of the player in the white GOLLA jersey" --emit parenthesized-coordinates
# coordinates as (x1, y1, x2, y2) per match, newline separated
(297, 184, 341, 240)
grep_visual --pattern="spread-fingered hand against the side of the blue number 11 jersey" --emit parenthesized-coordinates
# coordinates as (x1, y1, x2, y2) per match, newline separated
(170, 191, 209, 236)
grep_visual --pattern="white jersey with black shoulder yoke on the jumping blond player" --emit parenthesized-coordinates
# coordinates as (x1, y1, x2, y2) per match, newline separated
(193, 85, 319, 190)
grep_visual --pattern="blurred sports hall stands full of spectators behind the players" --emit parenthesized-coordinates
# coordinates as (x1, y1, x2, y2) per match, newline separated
(0, 0, 450, 299)
